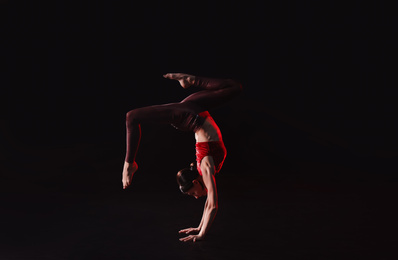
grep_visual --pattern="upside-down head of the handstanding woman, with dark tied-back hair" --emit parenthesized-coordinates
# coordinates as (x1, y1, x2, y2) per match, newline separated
(177, 163, 207, 198)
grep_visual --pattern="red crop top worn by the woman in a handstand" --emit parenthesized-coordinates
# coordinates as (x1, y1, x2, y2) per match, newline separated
(196, 141, 227, 175)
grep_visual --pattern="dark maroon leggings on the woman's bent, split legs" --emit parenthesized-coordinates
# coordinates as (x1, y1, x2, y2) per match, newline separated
(125, 77, 242, 163)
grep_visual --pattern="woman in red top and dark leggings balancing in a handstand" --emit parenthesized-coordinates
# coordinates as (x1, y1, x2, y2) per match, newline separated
(122, 73, 242, 242)
